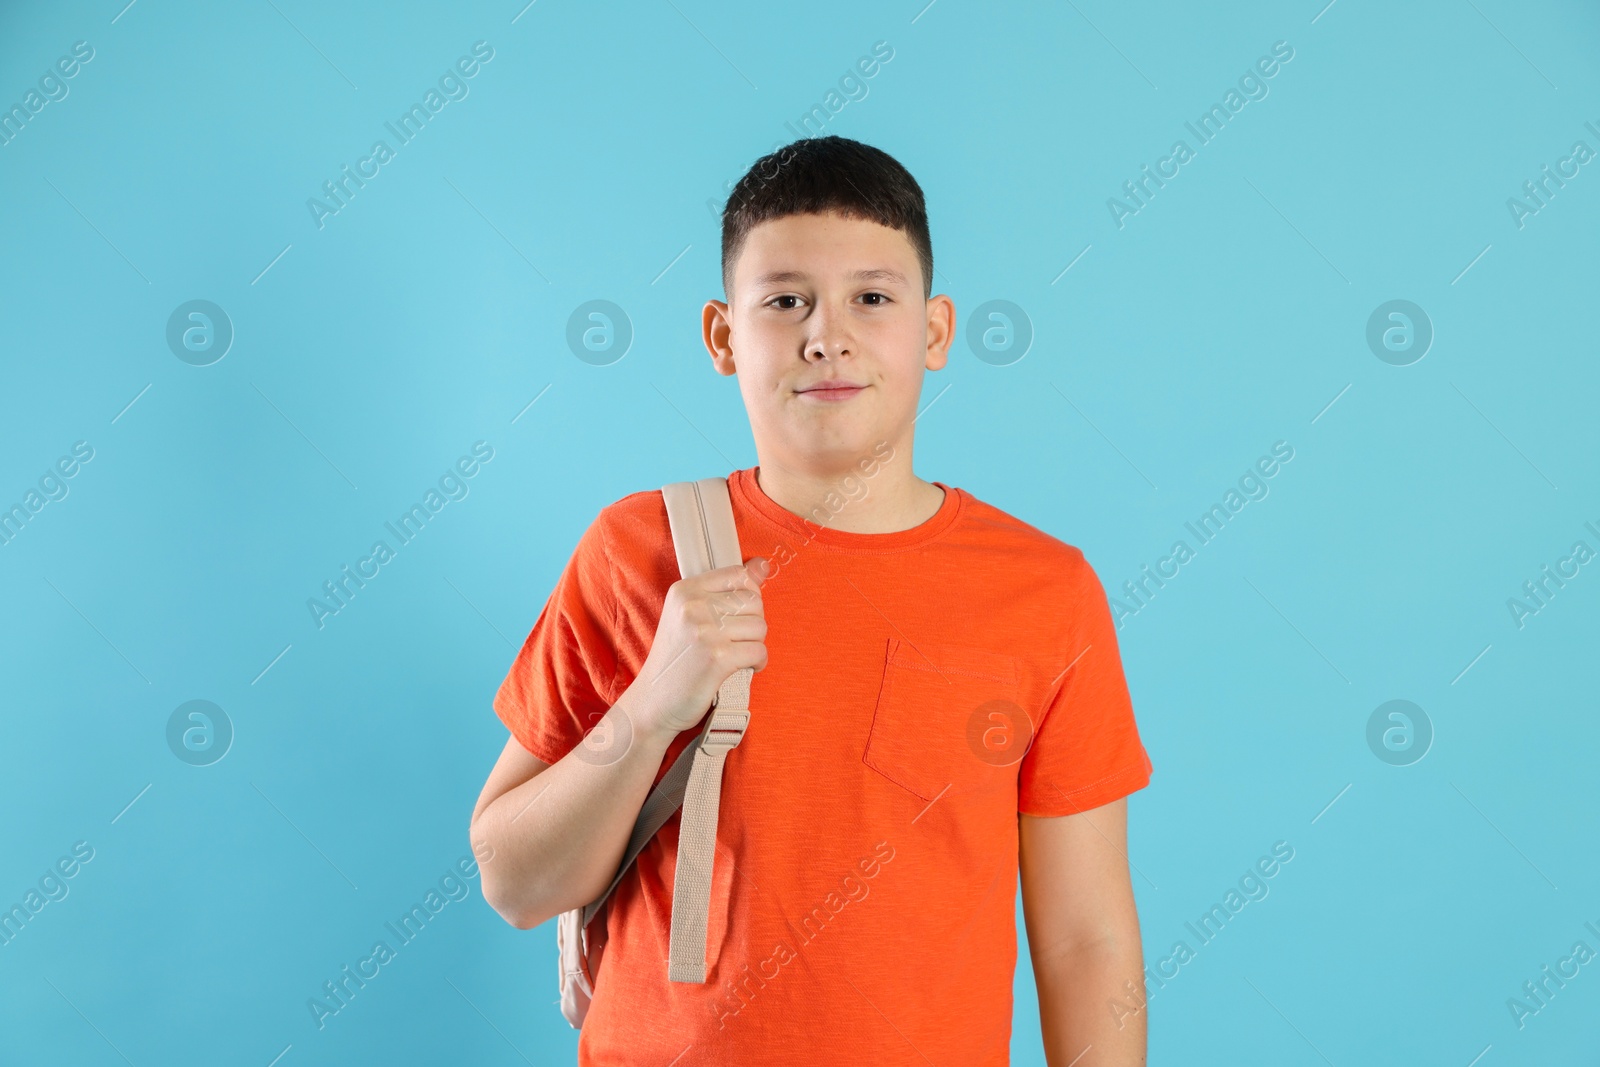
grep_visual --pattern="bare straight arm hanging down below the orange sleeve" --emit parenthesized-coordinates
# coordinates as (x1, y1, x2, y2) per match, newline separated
(1018, 798, 1146, 1067)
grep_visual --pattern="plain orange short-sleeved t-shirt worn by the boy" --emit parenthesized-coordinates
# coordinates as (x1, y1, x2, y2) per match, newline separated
(494, 467, 1150, 1067)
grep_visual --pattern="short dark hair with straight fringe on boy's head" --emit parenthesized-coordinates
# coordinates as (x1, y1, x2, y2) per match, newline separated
(722, 134, 933, 299)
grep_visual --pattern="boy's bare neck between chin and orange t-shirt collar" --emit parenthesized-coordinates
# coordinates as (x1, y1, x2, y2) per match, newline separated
(755, 448, 944, 534)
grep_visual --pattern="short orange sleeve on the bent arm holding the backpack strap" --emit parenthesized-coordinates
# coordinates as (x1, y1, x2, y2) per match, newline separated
(494, 512, 616, 763)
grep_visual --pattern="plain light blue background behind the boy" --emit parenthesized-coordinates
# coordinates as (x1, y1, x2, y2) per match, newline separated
(0, 0, 1600, 1067)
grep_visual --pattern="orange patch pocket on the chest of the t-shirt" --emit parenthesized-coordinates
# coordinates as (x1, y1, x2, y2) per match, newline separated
(861, 637, 1030, 801)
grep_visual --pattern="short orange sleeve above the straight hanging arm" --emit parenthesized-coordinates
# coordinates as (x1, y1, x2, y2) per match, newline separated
(1018, 552, 1152, 816)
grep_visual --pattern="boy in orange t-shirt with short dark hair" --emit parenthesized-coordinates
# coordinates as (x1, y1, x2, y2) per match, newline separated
(470, 136, 1150, 1067)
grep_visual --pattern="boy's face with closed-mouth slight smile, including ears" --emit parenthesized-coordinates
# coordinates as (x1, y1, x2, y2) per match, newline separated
(702, 211, 955, 475)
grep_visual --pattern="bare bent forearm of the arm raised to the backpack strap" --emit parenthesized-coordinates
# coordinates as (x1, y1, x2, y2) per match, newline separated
(472, 693, 675, 929)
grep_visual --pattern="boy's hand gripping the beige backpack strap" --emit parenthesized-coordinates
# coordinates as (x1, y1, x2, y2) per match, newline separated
(618, 557, 771, 741)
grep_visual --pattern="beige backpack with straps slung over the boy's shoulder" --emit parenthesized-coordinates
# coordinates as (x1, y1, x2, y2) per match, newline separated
(555, 478, 754, 1030)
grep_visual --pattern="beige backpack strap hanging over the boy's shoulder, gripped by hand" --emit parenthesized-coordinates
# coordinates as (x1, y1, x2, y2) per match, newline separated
(661, 478, 754, 982)
